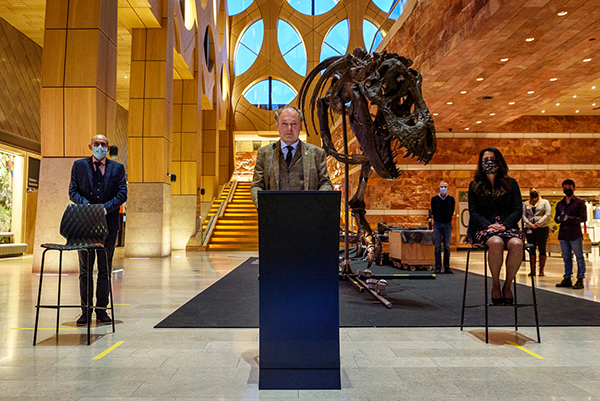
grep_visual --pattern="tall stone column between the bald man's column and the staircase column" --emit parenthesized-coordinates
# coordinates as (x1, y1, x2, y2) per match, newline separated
(125, 1, 174, 257)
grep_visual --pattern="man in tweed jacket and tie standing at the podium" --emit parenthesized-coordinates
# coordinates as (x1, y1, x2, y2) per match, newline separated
(250, 106, 333, 207)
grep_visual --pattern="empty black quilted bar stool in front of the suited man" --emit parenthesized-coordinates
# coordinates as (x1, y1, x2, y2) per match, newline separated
(33, 204, 115, 346)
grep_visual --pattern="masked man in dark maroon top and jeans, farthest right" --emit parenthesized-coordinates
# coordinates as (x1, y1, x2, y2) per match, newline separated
(554, 180, 587, 290)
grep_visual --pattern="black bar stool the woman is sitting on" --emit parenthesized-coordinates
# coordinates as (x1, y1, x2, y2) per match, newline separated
(460, 244, 542, 343)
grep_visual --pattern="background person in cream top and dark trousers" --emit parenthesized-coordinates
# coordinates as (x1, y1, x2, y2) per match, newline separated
(523, 187, 551, 276)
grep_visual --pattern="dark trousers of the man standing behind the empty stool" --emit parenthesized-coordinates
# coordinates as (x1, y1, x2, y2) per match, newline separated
(79, 231, 119, 312)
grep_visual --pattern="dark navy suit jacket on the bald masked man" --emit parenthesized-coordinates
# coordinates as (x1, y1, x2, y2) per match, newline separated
(69, 156, 127, 232)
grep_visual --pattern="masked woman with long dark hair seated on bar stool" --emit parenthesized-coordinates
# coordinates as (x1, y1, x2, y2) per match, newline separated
(469, 148, 524, 305)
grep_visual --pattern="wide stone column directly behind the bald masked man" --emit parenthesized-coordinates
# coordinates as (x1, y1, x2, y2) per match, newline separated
(33, 0, 118, 272)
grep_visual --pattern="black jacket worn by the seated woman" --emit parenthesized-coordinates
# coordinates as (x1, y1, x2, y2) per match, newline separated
(468, 178, 523, 238)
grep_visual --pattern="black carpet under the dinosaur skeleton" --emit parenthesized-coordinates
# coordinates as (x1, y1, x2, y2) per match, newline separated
(155, 258, 600, 328)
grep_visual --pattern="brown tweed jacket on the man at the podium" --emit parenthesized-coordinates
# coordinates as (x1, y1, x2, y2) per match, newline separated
(250, 141, 333, 205)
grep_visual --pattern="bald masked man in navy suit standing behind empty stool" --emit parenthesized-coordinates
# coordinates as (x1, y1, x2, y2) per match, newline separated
(69, 135, 127, 326)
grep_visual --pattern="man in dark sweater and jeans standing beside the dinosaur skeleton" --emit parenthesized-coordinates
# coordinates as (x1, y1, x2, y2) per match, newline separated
(431, 181, 454, 274)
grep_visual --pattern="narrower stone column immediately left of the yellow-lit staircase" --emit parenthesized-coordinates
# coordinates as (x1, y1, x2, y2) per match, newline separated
(171, 72, 202, 249)
